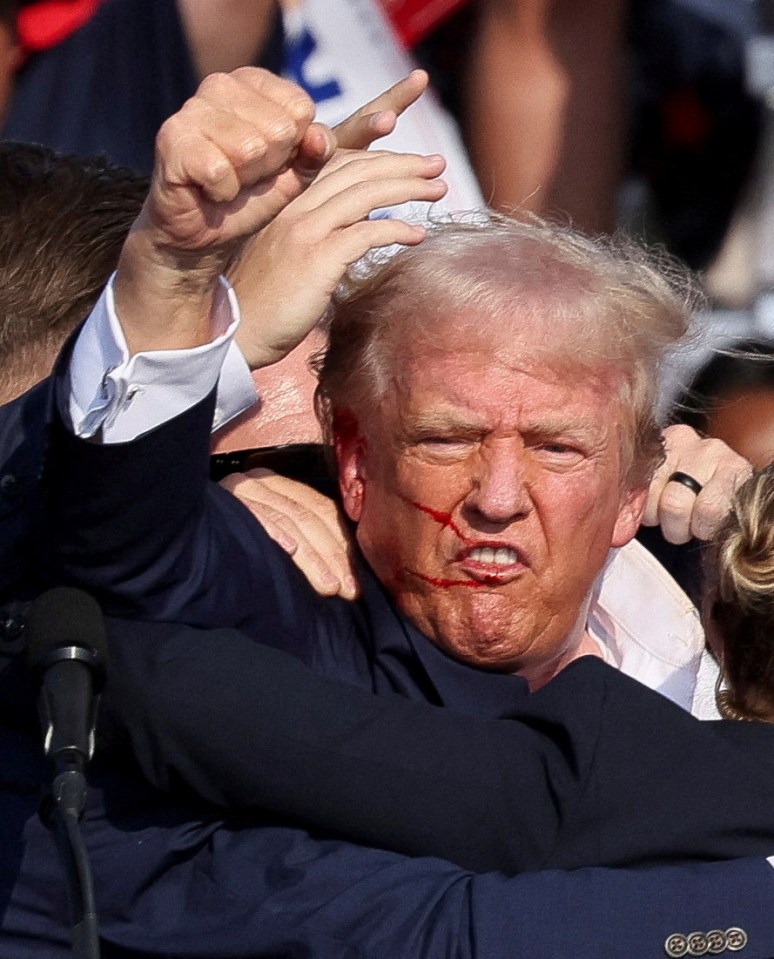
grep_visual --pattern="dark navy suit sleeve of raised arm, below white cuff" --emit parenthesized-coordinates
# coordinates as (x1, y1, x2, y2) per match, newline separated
(41, 395, 324, 643)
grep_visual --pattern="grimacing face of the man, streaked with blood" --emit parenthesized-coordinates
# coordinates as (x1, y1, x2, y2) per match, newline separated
(337, 322, 645, 685)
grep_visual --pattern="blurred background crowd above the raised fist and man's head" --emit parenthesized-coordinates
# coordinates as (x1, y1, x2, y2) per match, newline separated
(0, 0, 769, 464)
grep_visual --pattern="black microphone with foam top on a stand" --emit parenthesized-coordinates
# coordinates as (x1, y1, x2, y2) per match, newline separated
(27, 586, 107, 819)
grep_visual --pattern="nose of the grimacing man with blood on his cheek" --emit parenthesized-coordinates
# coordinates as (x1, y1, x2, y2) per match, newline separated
(460, 440, 532, 526)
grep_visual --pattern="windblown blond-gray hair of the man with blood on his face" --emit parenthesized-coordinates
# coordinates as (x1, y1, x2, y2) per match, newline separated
(316, 211, 700, 487)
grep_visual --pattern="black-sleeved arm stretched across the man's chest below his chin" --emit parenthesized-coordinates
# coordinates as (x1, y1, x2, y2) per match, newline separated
(98, 622, 774, 873)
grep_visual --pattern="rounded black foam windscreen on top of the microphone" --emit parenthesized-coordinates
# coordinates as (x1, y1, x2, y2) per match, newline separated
(27, 586, 107, 669)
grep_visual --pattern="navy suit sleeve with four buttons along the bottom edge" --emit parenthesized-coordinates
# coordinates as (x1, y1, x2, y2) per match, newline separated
(7, 784, 774, 959)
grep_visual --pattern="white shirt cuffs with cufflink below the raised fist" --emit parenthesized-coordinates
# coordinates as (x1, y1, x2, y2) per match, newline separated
(61, 278, 257, 443)
